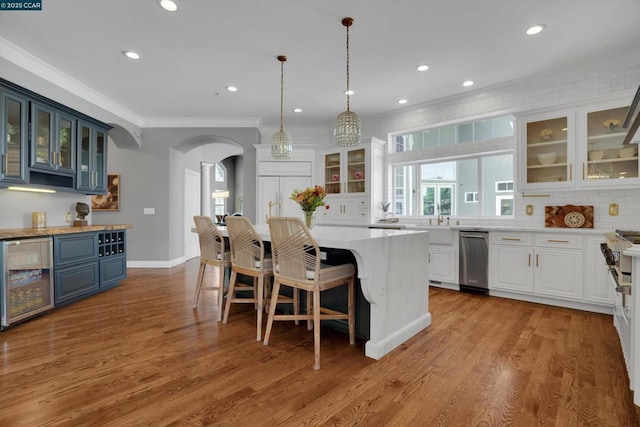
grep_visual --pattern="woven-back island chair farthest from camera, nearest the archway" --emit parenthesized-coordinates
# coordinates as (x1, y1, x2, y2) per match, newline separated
(193, 215, 231, 321)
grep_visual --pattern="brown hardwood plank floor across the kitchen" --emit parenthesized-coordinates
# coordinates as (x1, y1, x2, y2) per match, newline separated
(0, 259, 638, 427)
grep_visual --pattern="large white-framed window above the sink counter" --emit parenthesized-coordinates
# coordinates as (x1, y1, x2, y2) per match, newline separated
(387, 116, 515, 218)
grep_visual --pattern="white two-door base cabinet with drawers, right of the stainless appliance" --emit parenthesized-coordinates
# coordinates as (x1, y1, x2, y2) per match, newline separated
(489, 233, 584, 300)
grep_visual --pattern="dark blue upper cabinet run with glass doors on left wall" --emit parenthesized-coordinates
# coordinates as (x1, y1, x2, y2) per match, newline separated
(0, 78, 110, 194)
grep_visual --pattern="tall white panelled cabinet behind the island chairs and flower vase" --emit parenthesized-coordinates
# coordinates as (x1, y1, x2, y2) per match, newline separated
(255, 144, 315, 224)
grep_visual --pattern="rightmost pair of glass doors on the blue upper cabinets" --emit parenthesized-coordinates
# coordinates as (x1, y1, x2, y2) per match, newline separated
(77, 121, 107, 194)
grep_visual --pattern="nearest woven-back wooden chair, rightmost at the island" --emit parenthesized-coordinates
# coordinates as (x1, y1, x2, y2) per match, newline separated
(264, 217, 356, 370)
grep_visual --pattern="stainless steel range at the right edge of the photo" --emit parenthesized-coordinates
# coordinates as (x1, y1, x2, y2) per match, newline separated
(600, 230, 640, 382)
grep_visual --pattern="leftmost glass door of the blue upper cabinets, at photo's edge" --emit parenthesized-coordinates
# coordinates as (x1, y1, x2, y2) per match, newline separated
(0, 88, 29, 183)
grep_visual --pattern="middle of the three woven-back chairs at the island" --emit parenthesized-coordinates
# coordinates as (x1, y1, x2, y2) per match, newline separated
(222, 216, 273, 341)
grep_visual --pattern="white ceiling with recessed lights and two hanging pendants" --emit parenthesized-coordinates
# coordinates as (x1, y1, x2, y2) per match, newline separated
(0, 0, 640, 128)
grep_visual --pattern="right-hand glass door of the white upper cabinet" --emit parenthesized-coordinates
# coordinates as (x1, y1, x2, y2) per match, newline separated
(579, 106, 638, 186)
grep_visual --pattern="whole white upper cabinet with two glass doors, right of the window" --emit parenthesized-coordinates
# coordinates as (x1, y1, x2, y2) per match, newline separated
(518, 100, 640, 191)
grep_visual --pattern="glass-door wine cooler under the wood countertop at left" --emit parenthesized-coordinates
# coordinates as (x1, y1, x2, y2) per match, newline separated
(0, 237, 53, 329)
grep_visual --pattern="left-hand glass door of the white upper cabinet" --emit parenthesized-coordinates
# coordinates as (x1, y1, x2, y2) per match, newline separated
(520, 114, 574, 188)
